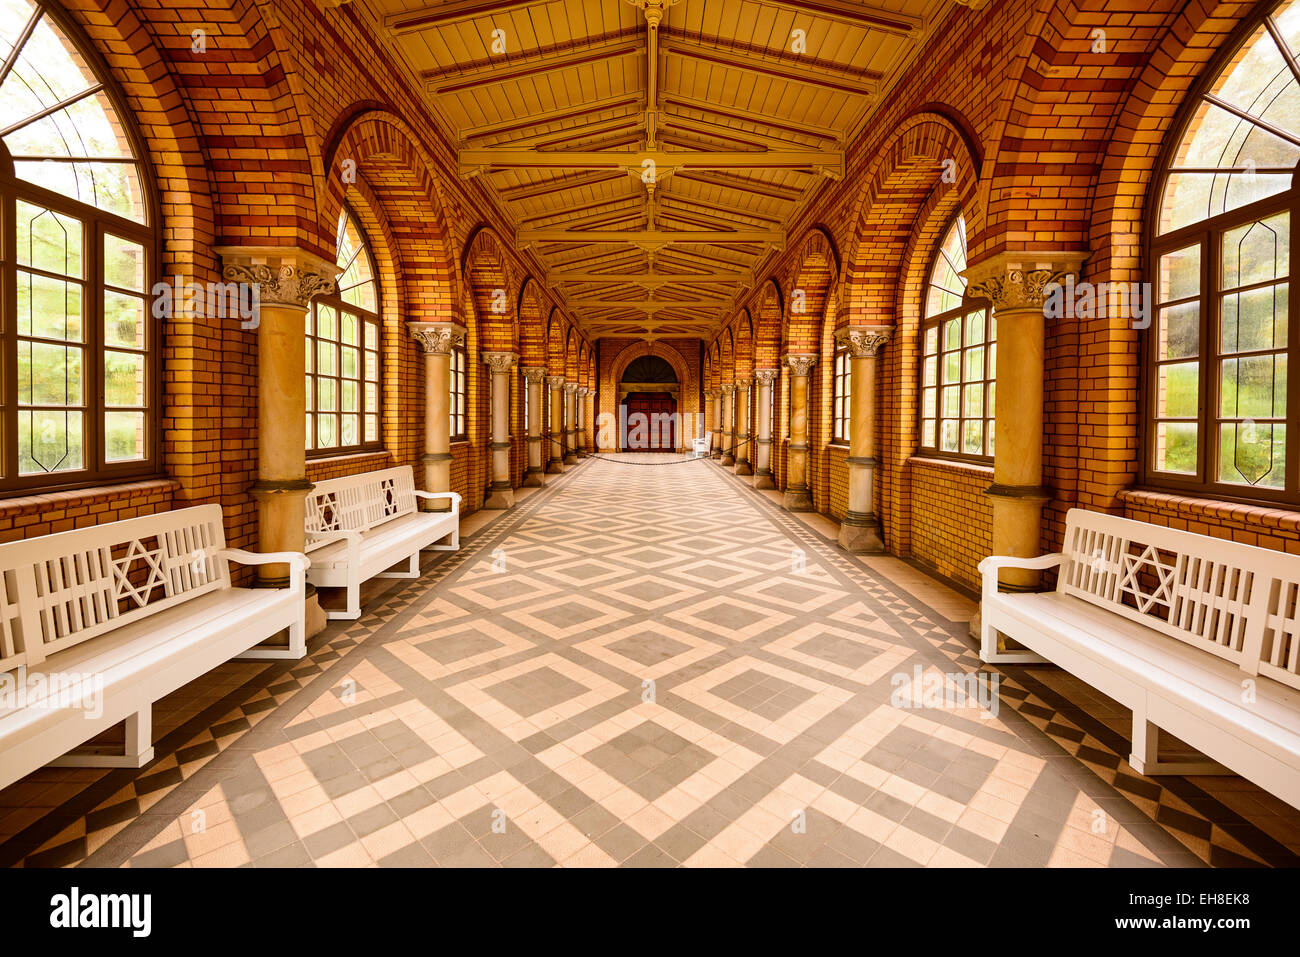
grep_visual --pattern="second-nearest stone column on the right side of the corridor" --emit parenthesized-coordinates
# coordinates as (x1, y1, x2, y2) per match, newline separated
(835, 325, 893, 551)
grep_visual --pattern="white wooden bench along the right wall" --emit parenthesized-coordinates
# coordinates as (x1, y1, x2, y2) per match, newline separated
(980, 508, 1300, 807)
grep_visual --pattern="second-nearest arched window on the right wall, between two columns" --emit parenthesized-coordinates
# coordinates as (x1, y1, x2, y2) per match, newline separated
(920, 216, 997, 459)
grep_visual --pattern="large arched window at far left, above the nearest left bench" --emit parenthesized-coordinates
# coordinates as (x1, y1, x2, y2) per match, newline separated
(0, 0, 155, 492)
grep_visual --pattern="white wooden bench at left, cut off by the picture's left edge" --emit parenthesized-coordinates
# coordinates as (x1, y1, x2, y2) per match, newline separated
(0, 505, 308, 788)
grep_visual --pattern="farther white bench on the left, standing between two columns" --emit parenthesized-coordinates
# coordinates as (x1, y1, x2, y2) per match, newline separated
(307, 465, 460, 619)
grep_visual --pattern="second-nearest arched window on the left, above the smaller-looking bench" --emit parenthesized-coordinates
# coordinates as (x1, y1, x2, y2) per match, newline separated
(307, 207, 382, 455)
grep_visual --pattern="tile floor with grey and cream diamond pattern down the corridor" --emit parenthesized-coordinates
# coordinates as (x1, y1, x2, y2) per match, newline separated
(0, 456, 1300, 867)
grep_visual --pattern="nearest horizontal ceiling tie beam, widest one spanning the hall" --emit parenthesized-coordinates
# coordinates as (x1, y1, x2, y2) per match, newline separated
(460, 147, 844, 179)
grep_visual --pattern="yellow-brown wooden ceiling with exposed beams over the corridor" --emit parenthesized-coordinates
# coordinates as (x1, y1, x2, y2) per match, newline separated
(359, 0, 950, 339)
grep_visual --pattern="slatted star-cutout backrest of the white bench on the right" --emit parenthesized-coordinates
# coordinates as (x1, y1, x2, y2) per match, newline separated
(1057, 508, 1300, 688)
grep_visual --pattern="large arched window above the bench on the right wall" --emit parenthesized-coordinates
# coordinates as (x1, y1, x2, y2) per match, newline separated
(1143, 0, 1300, 505)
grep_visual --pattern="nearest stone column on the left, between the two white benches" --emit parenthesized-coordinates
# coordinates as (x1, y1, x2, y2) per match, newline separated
(216, 246, 338, 590)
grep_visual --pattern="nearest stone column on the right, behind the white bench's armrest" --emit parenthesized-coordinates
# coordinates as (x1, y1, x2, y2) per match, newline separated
(962, 252, 1087, 590)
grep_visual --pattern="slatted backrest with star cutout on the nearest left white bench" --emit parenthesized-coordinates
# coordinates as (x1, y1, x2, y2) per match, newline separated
(0, 505, 230, 672)
